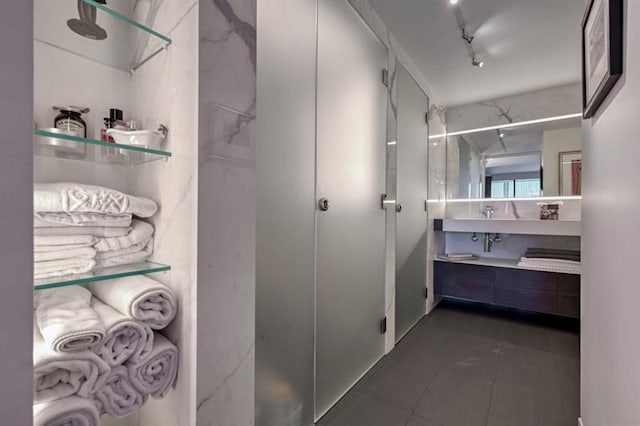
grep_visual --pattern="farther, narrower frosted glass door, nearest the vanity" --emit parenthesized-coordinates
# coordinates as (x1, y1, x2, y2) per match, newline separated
(396, 67, 429, 341)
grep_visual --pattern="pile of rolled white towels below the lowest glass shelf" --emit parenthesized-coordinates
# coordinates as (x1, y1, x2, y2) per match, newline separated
(33, 275, 178, 426)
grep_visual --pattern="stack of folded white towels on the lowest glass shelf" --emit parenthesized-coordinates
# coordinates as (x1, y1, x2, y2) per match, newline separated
(33, 183, 158, 280)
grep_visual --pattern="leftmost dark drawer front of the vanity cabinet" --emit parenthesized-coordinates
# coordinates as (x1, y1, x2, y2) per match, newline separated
(434, 262, 495, 303)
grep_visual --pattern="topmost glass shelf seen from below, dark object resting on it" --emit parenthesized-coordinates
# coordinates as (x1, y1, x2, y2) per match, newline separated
(34, 0, 171, 72)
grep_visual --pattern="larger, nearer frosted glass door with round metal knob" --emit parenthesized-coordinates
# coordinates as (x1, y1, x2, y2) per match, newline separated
(316, 0, 387, 417)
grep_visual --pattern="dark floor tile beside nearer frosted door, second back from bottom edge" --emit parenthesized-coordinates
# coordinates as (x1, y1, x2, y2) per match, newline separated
(358, 352, 442, 411)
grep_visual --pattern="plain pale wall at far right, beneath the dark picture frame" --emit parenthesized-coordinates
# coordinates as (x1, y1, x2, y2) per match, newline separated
(580, 0, 640, 426)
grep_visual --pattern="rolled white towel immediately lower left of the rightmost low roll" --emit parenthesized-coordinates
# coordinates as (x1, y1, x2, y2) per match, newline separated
(94, 366, 148, 417)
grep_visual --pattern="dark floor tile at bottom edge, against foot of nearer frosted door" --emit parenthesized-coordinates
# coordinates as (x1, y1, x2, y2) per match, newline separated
(317, 391, 411, 426)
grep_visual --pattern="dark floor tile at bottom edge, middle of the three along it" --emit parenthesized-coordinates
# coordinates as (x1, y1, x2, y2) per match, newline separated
(415, 369, 492, 426)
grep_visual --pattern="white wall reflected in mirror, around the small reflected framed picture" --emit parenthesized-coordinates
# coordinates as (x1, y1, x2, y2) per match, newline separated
(542, 127, 582, 197)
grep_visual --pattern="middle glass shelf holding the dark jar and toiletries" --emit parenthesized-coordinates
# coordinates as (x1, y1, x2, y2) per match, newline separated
(33, 130, 171, 166)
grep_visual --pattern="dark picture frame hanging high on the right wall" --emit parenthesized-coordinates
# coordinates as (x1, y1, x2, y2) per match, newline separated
(582, 0, 624, 119)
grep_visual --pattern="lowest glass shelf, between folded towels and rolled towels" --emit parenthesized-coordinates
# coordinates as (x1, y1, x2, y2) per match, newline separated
(33, 261, 171, 290)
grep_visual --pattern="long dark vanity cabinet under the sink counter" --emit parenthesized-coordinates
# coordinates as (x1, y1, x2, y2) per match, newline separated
(433, 261, 580, 318)
